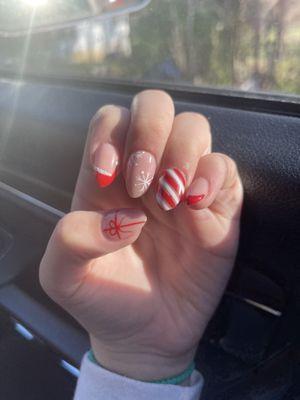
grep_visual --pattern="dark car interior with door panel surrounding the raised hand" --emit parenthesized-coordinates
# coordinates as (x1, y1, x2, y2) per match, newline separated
(0, 1, 300, 400)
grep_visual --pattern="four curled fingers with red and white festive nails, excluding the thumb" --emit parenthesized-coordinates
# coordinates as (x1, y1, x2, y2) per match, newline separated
(79, 90, 242, 219)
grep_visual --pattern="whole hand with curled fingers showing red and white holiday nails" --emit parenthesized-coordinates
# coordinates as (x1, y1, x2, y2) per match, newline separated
(40, 90, 243, 380)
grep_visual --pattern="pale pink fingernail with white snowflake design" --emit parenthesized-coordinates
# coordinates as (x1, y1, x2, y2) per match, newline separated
(126, 151, 156, 197)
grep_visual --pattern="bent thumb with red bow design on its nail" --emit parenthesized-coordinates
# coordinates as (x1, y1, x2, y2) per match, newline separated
(39, 208, 147, 301)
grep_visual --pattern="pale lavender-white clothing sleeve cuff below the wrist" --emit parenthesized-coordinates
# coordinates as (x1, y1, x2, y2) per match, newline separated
(74, 354, 203, 400)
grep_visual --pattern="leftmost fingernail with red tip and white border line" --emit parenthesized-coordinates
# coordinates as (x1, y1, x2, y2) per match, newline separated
(93, 143, 119, 187)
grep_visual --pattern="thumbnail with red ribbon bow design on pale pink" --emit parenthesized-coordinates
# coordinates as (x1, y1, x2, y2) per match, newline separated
(102, 208, 147, 240)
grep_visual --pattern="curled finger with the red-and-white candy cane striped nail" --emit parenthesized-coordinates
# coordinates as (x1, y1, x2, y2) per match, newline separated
(156, 112, 211, 211)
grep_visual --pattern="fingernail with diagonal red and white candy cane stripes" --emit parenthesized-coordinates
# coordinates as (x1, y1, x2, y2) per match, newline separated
(156, 168, 186, 211)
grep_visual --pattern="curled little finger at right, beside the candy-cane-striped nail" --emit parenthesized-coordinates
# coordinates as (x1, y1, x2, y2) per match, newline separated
(185, 153, 243, 217)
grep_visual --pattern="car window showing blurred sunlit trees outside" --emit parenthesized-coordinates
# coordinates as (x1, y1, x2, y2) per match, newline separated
(0, 0, 300, 95)
